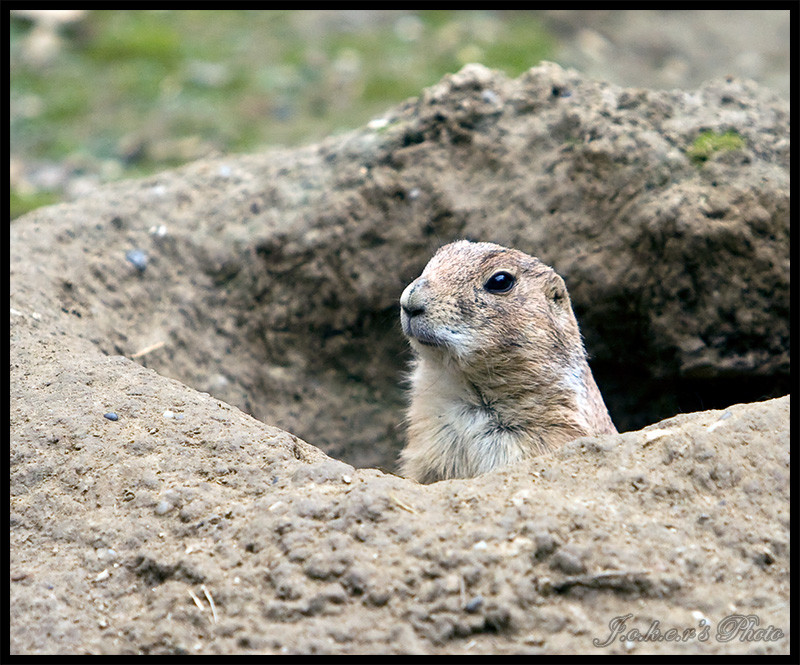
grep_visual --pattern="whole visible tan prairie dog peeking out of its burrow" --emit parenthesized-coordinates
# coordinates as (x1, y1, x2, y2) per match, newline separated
(400, 240, 617, 482)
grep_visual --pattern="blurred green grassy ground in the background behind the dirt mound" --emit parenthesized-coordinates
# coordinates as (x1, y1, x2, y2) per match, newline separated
(10, 10, 555, 218)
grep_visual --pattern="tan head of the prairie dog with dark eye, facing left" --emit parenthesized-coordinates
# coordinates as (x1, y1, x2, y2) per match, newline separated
(400, 240, 584, 371)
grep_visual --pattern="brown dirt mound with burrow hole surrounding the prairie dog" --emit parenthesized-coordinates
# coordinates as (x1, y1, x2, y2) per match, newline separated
(11, 65, 789, 653)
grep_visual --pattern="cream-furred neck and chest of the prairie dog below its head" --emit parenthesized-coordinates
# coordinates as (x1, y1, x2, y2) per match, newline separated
(403, 349, 596, 482)
